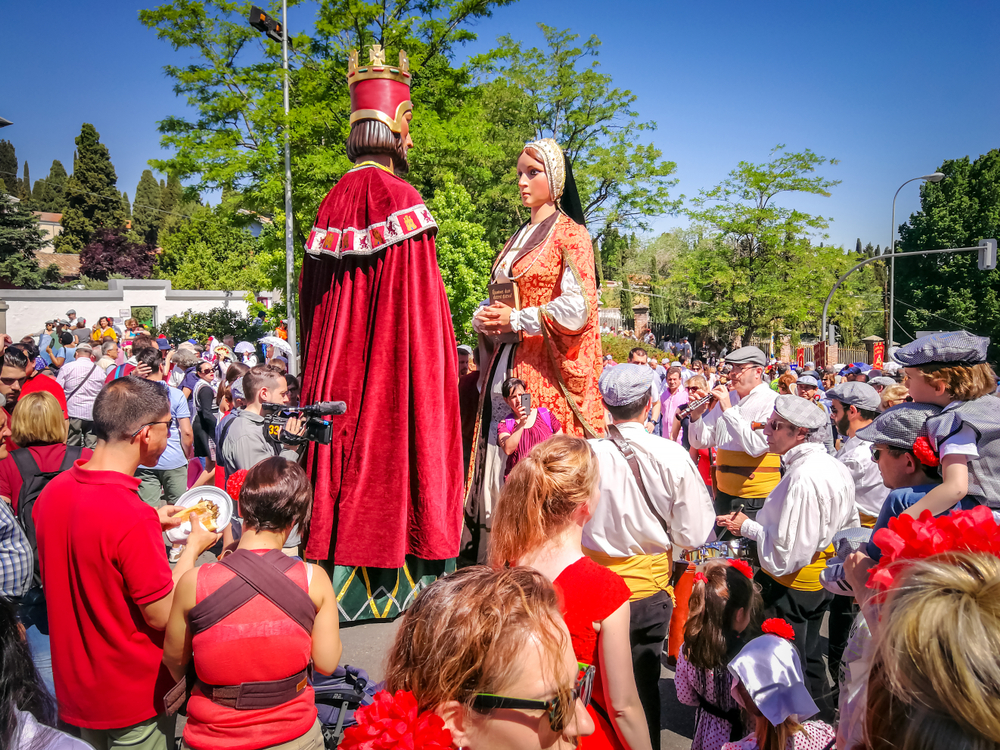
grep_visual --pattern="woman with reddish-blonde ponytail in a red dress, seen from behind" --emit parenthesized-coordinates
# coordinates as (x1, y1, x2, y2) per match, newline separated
(489, 435, 651, 750)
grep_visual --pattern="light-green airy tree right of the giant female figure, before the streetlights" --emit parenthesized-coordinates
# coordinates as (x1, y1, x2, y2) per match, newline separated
(675, 146, 845, 341)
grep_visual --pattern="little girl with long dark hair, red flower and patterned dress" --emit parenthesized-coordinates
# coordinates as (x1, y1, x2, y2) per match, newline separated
(674, 561, 761, 750)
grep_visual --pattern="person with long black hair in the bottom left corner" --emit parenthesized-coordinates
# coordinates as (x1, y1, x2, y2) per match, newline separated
(0, 598, 91, 750)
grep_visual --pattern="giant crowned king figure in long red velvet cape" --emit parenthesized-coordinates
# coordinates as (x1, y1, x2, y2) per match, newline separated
(299, 45, 463, 620)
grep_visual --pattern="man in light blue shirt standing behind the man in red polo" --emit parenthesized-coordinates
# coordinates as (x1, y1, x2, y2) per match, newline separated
(135, 349, 194, 508)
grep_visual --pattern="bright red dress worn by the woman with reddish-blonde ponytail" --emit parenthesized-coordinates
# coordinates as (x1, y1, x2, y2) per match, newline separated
(554, 557, 631, 750)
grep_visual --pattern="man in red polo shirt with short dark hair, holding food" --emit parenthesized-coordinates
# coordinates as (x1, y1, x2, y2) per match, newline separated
(34, 378, 219, 750)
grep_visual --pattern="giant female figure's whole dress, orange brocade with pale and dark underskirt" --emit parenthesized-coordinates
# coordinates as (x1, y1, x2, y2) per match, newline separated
(463, 212, 604, 561)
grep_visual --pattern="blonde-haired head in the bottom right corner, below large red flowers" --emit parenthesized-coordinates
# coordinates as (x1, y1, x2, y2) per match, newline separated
(863, 553, 1000, 750)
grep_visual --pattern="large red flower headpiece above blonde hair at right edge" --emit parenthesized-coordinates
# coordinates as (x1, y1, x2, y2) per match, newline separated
(868, 505, 1000, 590)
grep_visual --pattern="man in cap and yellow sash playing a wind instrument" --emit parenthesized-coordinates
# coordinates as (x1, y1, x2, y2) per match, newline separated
(688, 346, 781, 539)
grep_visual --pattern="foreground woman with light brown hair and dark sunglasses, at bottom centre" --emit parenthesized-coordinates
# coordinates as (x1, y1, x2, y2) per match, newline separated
(378, 566, 594, 750)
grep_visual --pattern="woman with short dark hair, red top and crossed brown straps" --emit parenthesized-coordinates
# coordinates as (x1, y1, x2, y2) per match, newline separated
(163, 457, 341, 750)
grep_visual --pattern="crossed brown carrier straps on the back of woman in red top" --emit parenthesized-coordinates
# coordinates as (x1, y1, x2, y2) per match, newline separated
(188, 549, 316, 634)
